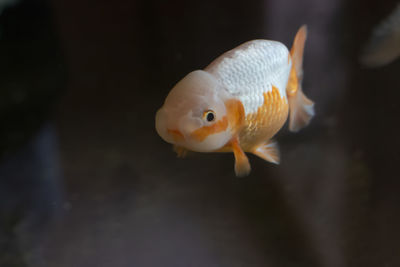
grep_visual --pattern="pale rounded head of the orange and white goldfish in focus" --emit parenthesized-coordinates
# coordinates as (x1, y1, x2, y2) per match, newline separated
(156, 70, 236, 152)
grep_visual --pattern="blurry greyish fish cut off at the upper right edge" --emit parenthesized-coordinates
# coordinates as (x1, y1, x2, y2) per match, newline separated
(360, 4, 400, 68)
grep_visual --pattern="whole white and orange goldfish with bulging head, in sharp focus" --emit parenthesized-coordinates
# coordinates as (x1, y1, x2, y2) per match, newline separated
(155, 25, 315, 177)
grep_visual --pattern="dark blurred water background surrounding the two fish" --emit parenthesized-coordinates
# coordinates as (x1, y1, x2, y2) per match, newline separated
(0, 0, 400, 267)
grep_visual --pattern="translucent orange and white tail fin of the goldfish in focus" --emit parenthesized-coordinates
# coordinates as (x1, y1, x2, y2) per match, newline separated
(286, 25, 314, 132)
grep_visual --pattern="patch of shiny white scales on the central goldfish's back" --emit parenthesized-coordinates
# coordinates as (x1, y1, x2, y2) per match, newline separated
(205, 40, 291, 115)
